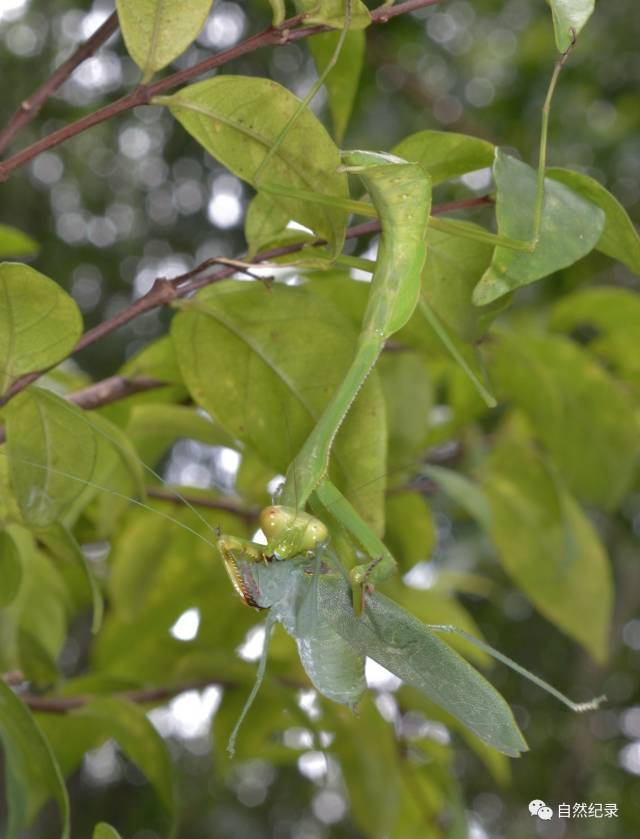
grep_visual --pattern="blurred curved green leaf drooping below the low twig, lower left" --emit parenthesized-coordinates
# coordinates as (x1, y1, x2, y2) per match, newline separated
(75, 697, 176, 835)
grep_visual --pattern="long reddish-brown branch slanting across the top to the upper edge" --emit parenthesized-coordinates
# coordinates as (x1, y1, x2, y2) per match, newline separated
(0, 0, 440, 181)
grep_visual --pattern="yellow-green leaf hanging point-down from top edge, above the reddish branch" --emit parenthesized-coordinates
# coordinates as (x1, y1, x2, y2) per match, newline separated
(116, 0, 212, 83)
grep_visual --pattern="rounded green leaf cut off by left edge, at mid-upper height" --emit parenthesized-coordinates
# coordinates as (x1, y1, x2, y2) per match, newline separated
(0, 262, 82, 393)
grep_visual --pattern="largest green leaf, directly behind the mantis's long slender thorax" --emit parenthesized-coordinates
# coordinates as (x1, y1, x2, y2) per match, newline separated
(172, 282, 386, 532)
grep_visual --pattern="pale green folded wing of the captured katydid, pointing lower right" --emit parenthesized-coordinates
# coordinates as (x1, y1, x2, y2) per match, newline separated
(318, 575, 527, 757)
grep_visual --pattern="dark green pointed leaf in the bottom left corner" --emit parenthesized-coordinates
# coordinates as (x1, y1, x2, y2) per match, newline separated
(0, 679, 69, 839)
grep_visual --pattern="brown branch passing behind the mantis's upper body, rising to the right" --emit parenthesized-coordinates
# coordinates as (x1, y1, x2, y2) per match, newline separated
(0, 196, 491, 408)
